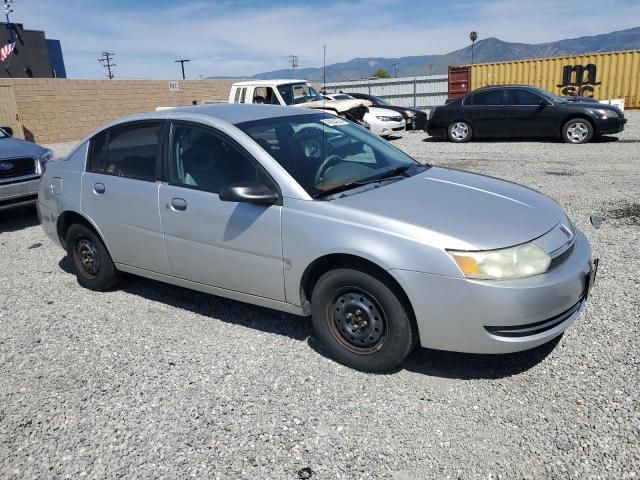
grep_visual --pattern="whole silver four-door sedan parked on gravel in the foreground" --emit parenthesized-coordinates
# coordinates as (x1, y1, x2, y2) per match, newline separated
(38, 105, 595, 371)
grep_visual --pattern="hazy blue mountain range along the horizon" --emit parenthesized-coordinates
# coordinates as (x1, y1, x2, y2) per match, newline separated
(209, 27, 640, 82)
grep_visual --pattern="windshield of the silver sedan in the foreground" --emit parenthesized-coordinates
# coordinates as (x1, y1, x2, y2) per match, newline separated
(237, 113, 429, 198)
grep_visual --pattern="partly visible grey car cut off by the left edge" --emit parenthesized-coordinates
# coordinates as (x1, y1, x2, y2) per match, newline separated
(0, 128, 53, 210)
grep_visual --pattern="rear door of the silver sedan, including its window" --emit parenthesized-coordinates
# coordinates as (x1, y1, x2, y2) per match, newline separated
(81, 121, 170, 273)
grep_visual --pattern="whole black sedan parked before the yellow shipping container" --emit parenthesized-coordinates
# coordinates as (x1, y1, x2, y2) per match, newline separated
(425, 85, 627, 143)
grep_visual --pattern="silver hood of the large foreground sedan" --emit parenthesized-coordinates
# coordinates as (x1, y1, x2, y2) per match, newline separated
(334, 167, 564, 250)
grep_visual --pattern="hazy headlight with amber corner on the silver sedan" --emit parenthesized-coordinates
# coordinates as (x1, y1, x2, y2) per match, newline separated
(448, 243, 551, 280)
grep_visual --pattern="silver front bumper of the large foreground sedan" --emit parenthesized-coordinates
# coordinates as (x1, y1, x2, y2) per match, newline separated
(390, 231, 593, 353)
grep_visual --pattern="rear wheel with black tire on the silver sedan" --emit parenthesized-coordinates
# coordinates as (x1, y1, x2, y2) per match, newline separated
(66, 224, 122, 291)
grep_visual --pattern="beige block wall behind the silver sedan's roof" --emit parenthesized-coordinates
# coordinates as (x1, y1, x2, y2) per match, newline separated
(0, 78, 238, 143)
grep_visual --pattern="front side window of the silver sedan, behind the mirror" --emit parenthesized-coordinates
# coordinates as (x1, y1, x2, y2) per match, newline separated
(171, 124, 273, 193)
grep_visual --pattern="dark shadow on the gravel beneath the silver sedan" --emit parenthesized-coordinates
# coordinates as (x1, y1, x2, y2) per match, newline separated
(59, 256, 561, 380)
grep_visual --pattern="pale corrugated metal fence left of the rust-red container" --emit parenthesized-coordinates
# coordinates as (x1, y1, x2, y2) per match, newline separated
(325, 75, 448, 109)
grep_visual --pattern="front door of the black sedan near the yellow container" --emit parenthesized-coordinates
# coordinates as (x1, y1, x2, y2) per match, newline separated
(507, 88, 557, 138)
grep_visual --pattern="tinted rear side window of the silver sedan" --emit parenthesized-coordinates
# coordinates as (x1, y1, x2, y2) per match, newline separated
(89, 122, 162, 181)
